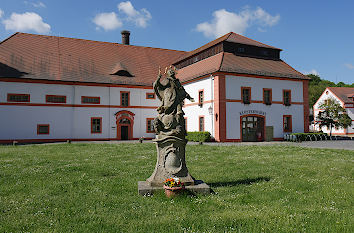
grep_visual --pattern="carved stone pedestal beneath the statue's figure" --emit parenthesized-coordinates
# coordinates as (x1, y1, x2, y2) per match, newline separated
(146, 136, 194, 186)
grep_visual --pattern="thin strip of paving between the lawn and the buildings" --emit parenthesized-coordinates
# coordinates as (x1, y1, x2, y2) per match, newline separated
(73, 140, 354, 150)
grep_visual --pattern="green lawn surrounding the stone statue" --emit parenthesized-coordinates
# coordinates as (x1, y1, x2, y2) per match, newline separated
(0, 143, 354, 232)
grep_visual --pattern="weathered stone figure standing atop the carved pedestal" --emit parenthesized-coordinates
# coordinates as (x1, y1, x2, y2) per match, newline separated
(153, 66, 194, 138)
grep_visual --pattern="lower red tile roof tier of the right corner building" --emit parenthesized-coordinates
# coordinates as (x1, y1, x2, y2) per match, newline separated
(177, 52, 310, 81)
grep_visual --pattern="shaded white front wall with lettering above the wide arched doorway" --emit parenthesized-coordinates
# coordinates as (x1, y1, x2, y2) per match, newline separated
(226, 76, 304, 139)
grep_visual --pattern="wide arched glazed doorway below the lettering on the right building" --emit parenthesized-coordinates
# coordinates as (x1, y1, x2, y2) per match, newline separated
(240, 114, 265, 142)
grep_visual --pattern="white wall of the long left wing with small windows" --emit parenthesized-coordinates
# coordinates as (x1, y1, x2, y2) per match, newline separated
(0, 82, 160, 141)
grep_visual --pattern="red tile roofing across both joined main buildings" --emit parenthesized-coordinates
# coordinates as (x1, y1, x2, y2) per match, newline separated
(0, 33, 308, 86)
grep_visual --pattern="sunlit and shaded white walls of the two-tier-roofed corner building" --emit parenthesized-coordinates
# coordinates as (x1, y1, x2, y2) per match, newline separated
(184, 75, 307, 141)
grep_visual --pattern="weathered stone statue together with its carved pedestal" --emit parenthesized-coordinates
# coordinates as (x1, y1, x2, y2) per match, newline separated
(146, 66, 194, 186)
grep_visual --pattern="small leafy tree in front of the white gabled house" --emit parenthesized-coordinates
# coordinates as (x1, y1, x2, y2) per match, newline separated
(316, 98, 352, 136)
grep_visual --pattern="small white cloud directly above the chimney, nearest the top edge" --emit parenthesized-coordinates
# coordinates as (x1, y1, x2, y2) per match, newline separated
(118, 1, 152, 28)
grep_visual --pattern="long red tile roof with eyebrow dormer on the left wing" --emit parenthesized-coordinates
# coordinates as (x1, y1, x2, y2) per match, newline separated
(0, 33, 186, 86)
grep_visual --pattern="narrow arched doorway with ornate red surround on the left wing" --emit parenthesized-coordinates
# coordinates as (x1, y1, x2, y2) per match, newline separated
(115, 110, 135, 140)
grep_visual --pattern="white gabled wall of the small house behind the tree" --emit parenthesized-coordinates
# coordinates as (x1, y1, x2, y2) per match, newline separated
(313, 88, 354, 136)
